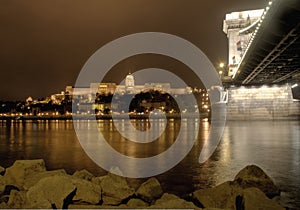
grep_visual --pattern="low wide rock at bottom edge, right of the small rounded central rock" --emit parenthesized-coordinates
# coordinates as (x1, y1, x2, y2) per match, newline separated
(150, 193, 200, 209)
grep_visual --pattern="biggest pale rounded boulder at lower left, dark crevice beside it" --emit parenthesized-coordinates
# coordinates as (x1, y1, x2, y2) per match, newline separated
(26, 175, 76, 208)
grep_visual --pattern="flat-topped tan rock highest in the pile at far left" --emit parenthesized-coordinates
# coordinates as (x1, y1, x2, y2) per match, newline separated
(4, 159, 46, 188)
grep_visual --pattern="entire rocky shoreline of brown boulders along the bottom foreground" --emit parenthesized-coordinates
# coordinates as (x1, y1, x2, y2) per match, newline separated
(0, 159, 285, 210)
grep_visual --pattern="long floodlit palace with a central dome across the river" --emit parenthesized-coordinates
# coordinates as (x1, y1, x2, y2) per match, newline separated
(65, 74, 209, 113)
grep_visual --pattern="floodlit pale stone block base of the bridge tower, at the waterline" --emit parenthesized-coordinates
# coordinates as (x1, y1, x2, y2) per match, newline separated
(227, 85, 300, 120)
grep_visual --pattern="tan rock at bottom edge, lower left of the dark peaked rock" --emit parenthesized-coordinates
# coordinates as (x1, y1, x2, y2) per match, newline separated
(193, 181, 243, 209)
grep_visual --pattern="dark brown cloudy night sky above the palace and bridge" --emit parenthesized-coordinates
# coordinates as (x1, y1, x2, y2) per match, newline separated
(0, 0, 266, 100)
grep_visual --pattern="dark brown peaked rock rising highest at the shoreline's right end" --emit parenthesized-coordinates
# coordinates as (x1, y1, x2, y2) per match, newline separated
(234, 165, 280, 198)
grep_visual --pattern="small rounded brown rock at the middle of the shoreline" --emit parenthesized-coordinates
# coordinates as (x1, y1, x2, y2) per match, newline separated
(136, 178, 163, 203)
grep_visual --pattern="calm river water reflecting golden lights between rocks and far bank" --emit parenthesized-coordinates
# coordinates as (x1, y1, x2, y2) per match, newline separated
(0, 120, 300, 209)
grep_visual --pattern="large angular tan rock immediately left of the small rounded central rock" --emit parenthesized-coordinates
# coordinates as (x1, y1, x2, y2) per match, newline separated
(100, 173, 134, 205)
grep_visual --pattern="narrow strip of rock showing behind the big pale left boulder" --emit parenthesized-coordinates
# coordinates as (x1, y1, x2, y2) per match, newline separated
(23, 169, 67, 190)
